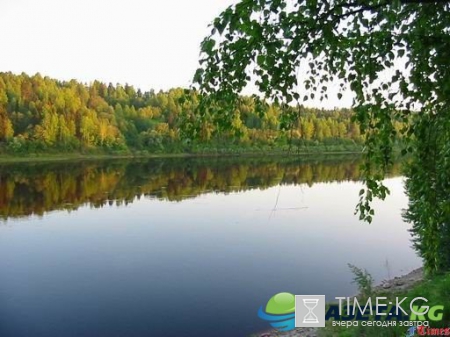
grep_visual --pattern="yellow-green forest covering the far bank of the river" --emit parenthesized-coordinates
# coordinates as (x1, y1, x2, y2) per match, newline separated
(0, 73, 384, 154)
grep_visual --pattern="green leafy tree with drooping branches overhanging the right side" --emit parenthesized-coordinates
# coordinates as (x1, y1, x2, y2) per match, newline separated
(194, 0, 450, 271)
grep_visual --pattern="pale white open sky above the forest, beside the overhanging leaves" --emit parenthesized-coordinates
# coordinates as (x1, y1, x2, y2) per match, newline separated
(0, 0, 351, 107)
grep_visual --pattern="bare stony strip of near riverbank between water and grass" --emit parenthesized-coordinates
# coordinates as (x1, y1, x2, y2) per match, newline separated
(251, 268, 426, 337)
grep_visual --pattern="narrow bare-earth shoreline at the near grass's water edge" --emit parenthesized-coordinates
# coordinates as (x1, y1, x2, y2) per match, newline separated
(250, 267, 424, 337)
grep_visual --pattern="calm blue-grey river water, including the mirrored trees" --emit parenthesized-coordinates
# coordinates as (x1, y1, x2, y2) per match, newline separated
(0, 158, 420, 337)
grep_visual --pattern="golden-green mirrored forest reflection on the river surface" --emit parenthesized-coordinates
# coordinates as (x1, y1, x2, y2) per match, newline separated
(0, 156, 399, 219)
